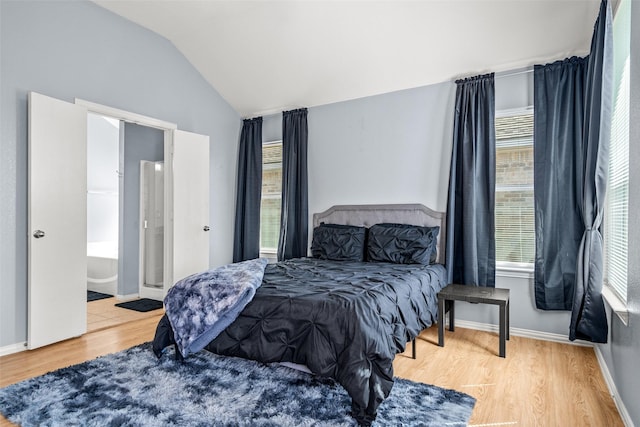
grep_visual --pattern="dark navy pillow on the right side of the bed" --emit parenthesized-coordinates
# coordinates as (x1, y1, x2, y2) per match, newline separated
(367, 224, 440, 265)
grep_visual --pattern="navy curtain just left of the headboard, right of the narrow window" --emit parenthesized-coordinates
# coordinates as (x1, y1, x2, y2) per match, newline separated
(278, 108, 309, 261)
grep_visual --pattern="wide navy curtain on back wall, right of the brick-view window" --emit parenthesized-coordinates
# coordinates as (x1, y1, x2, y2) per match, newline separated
(533, 57, 587, 310)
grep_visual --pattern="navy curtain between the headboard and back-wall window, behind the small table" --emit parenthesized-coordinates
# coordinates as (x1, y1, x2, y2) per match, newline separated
(446, 73, 496, 287)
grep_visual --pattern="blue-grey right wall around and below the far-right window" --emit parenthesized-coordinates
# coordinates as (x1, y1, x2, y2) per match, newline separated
(599, 1, 640, 426)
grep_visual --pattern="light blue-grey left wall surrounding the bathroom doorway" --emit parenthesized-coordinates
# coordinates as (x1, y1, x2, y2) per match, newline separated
(0, 0, 240, 348)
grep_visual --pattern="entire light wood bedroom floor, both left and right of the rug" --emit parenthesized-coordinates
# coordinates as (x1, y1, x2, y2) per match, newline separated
(0, 320, 623, 427)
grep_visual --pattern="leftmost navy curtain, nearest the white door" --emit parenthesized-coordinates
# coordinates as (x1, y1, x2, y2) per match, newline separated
(233, 117, 262, 262)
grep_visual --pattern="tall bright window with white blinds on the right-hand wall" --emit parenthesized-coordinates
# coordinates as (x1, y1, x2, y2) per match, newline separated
(603, 1, 631, 302)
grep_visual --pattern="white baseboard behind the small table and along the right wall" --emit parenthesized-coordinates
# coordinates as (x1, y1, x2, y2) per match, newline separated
(455, 320, 634, 427)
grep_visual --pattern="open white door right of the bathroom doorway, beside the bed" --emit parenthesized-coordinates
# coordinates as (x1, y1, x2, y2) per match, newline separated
(170, 130, 211, 294)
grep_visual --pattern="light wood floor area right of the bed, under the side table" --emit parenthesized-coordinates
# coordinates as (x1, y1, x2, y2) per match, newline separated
(394, 327, 624, 427)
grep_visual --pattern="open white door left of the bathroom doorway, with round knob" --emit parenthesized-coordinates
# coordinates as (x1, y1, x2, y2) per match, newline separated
(27, 92, 87, 349)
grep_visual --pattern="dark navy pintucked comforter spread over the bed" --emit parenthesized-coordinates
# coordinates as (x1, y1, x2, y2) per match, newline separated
(205, 258, 446, 425)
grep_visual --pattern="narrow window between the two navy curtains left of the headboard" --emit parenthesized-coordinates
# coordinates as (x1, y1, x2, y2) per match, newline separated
(260, 141, 282, 254)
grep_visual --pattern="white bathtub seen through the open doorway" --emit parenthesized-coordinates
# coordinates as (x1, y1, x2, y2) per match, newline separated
(87, 242, 118, 295)
